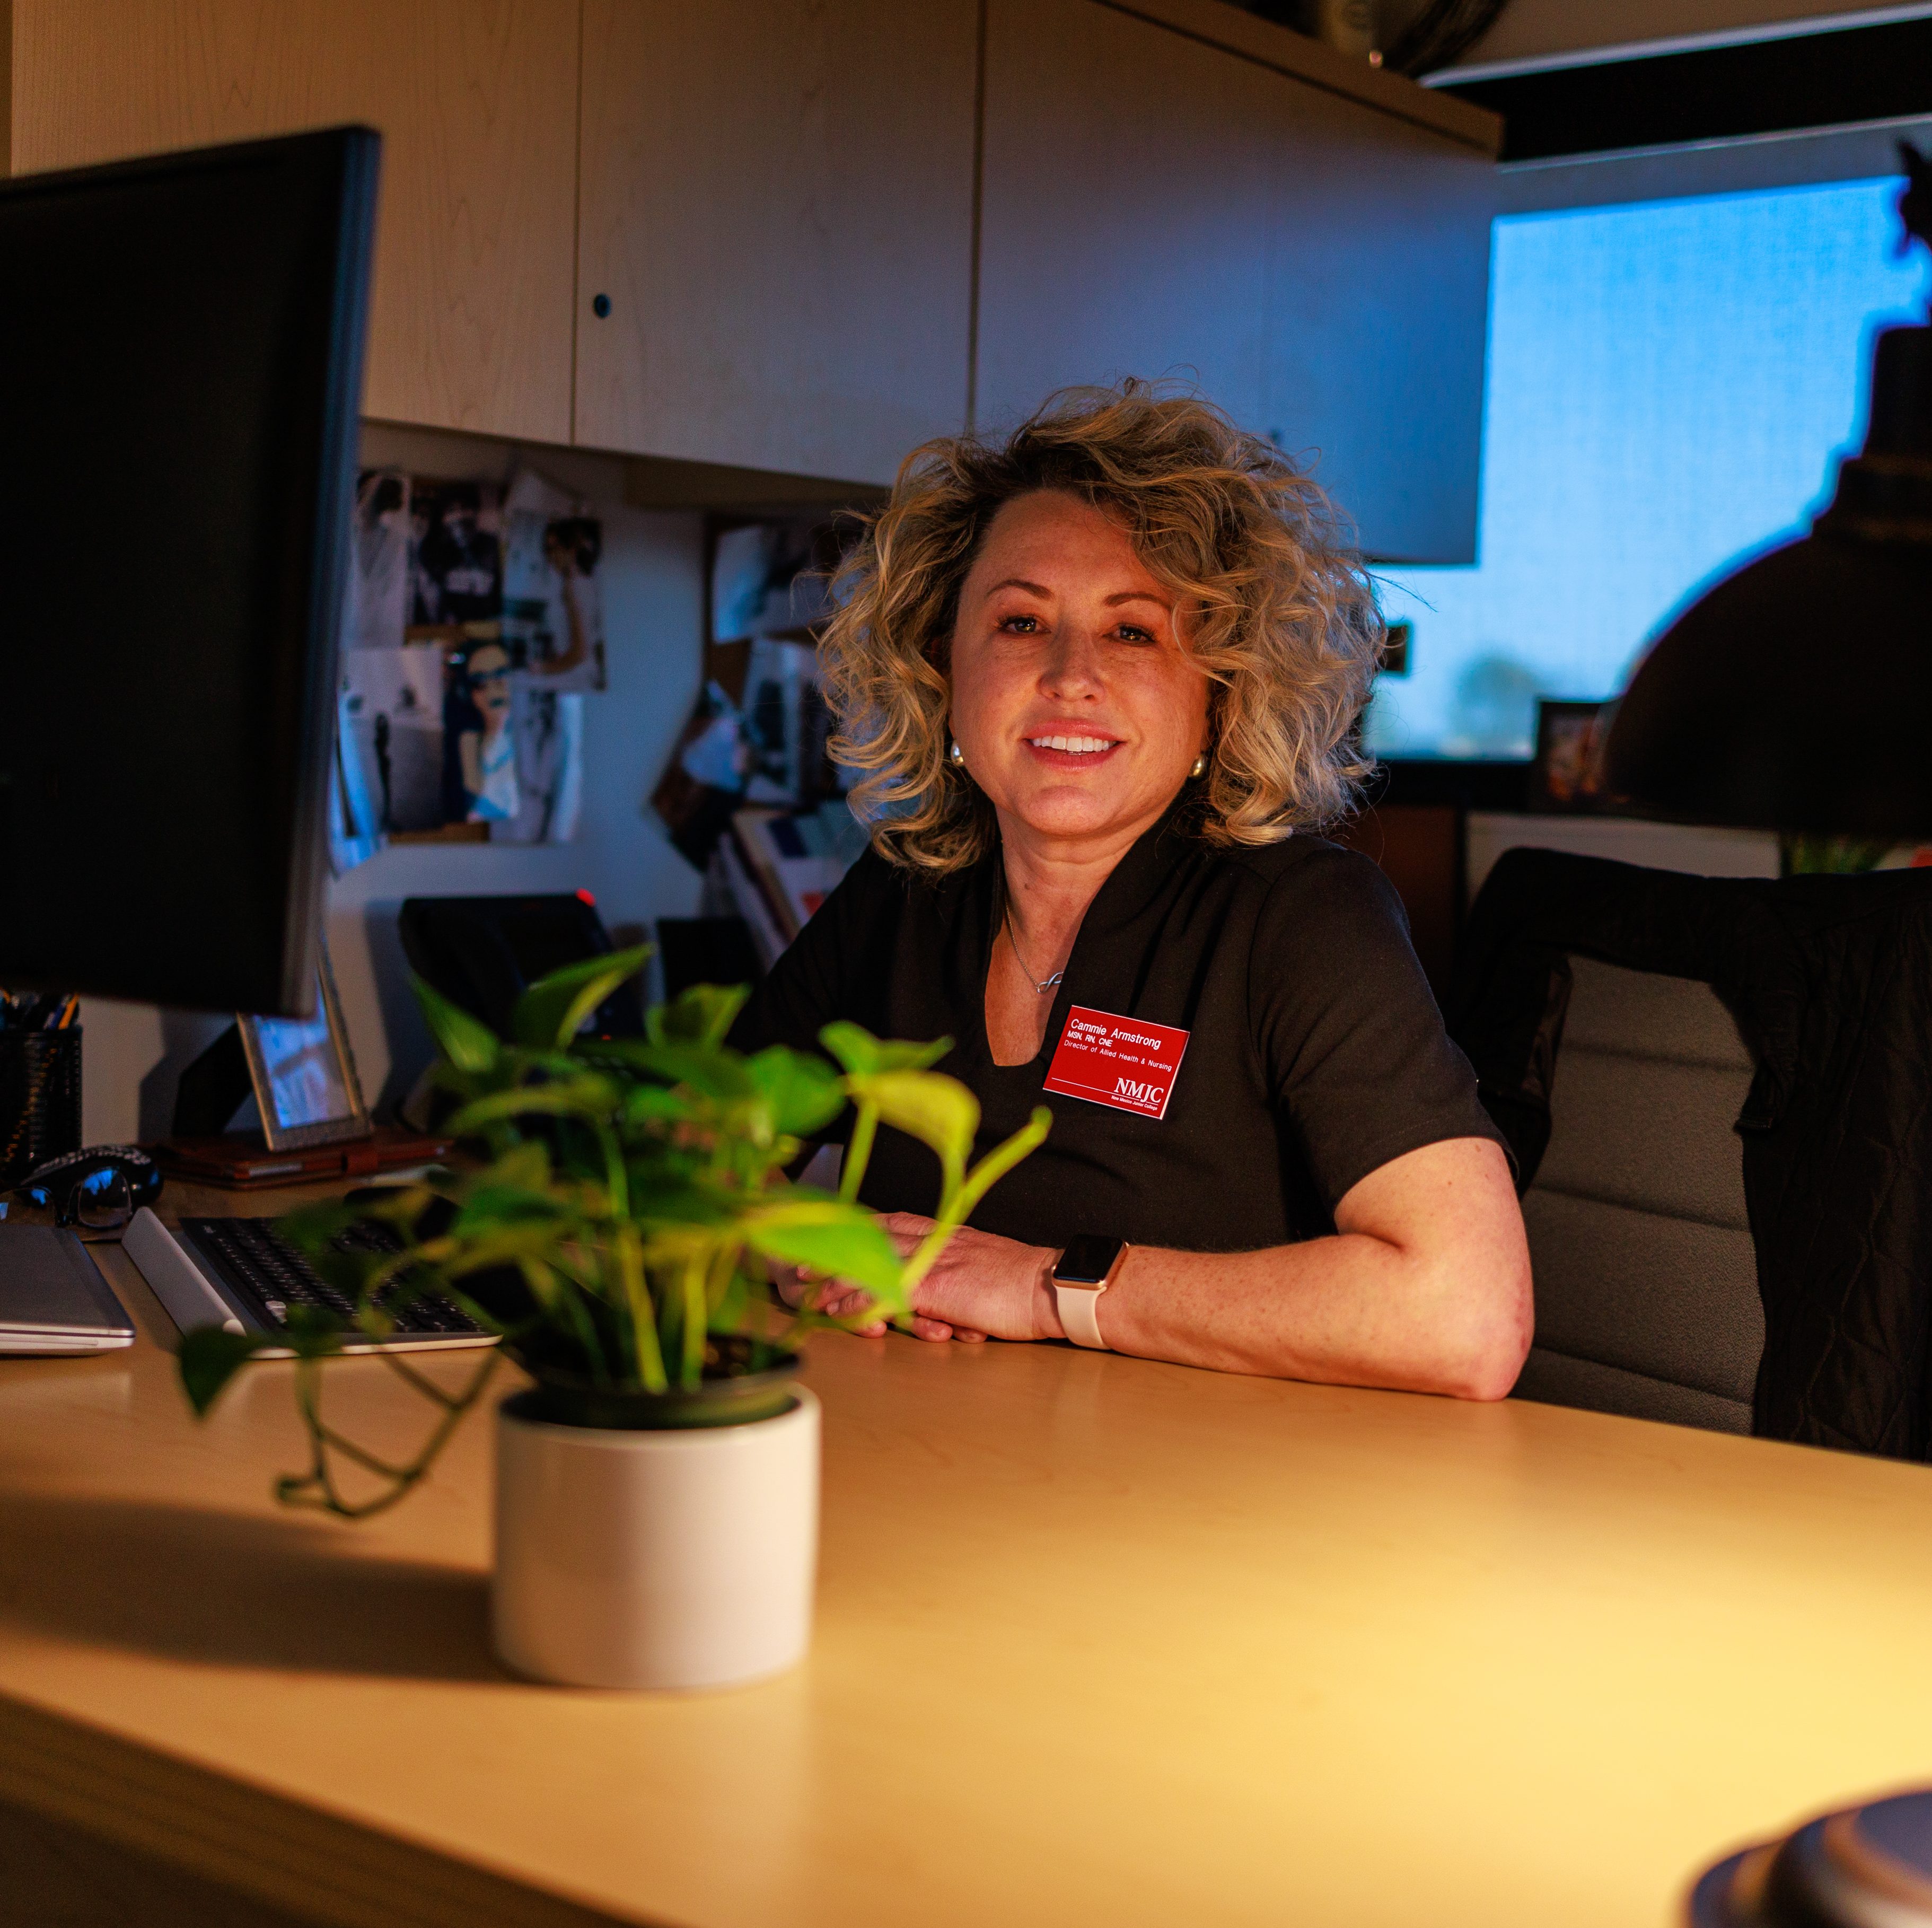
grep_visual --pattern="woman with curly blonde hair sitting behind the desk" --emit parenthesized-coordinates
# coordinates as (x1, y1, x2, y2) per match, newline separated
(734, 384, 1530, 1399)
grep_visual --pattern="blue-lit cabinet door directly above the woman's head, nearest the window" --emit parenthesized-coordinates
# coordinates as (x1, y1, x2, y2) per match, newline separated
(974, 0, 1494, 562)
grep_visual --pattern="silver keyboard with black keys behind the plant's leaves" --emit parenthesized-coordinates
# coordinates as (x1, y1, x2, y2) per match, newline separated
(124, 1211, 497, 1352)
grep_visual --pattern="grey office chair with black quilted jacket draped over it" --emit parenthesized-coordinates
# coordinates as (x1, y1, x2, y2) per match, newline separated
(1445, 850, 1932, 1459)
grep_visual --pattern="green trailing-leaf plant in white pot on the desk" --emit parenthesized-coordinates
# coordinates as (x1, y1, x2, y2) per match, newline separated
(180, 949, 1049, 1687)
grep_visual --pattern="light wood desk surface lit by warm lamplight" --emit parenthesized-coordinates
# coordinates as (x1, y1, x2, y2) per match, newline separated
(0, 1197, 1932, 1928)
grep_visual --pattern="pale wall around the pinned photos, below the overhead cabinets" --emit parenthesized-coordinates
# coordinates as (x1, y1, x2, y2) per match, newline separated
(81, 423, 703, 1144)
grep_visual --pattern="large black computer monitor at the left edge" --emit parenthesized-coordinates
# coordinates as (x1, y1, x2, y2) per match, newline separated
(0, 127, 381, 1016)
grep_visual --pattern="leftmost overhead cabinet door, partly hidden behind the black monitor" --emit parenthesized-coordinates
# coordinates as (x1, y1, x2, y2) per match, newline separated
(14, 0, 578, 442)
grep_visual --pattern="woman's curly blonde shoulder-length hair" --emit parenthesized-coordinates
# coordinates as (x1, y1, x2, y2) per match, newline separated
(819, 381, 1383, 875)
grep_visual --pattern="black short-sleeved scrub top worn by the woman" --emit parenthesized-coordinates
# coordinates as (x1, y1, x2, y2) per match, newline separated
(730, 813, 1503, 1252)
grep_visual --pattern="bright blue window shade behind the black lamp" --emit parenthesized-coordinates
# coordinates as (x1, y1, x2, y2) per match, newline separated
(1368, 180, 1926, 757)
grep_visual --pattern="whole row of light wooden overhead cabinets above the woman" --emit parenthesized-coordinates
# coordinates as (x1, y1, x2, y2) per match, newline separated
(0, 0, 1497, 529)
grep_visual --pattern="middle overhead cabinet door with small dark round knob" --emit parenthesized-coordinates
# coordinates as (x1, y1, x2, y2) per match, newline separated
(576, 0, 976, 483)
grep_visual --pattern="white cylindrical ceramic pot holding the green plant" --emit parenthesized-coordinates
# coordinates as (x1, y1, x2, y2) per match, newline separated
(491, 1387, 819, 1688)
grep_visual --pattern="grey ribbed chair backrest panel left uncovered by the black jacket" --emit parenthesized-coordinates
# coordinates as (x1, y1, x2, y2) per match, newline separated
(1515, 956, 1764, 1433)
